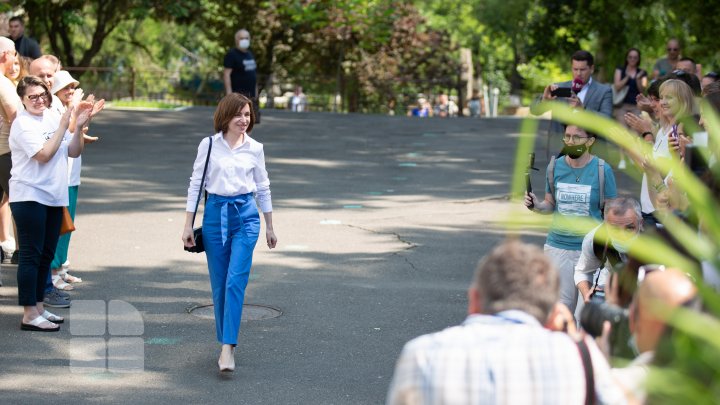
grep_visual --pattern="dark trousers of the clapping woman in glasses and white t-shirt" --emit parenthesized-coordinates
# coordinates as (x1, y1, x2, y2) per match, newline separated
(10, 201, 62, 306)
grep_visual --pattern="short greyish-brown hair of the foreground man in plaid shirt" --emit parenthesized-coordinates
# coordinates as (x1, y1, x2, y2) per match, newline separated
(473, 239, 560, 324)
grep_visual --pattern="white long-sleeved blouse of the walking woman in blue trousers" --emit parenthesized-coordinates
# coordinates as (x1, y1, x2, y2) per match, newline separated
(185, 132, 272, 212)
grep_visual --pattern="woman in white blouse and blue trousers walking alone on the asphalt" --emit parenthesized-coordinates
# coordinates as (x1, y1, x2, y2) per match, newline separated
(182, 93, 277, 371)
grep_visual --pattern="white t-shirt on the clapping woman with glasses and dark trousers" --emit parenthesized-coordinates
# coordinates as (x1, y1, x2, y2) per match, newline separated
(10, 110, 71, 207)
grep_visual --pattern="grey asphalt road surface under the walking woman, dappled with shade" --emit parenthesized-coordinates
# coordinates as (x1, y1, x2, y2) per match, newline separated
(0, 108, 632, 404)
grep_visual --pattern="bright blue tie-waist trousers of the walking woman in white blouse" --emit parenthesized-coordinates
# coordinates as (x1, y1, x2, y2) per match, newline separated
(203, 193, 260, 345)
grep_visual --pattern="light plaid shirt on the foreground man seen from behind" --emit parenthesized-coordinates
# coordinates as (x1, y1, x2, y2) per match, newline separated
(387, 311, 625, 405)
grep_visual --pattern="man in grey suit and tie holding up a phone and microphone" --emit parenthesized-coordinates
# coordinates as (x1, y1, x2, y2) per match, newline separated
(530, 50, 612, 156)
